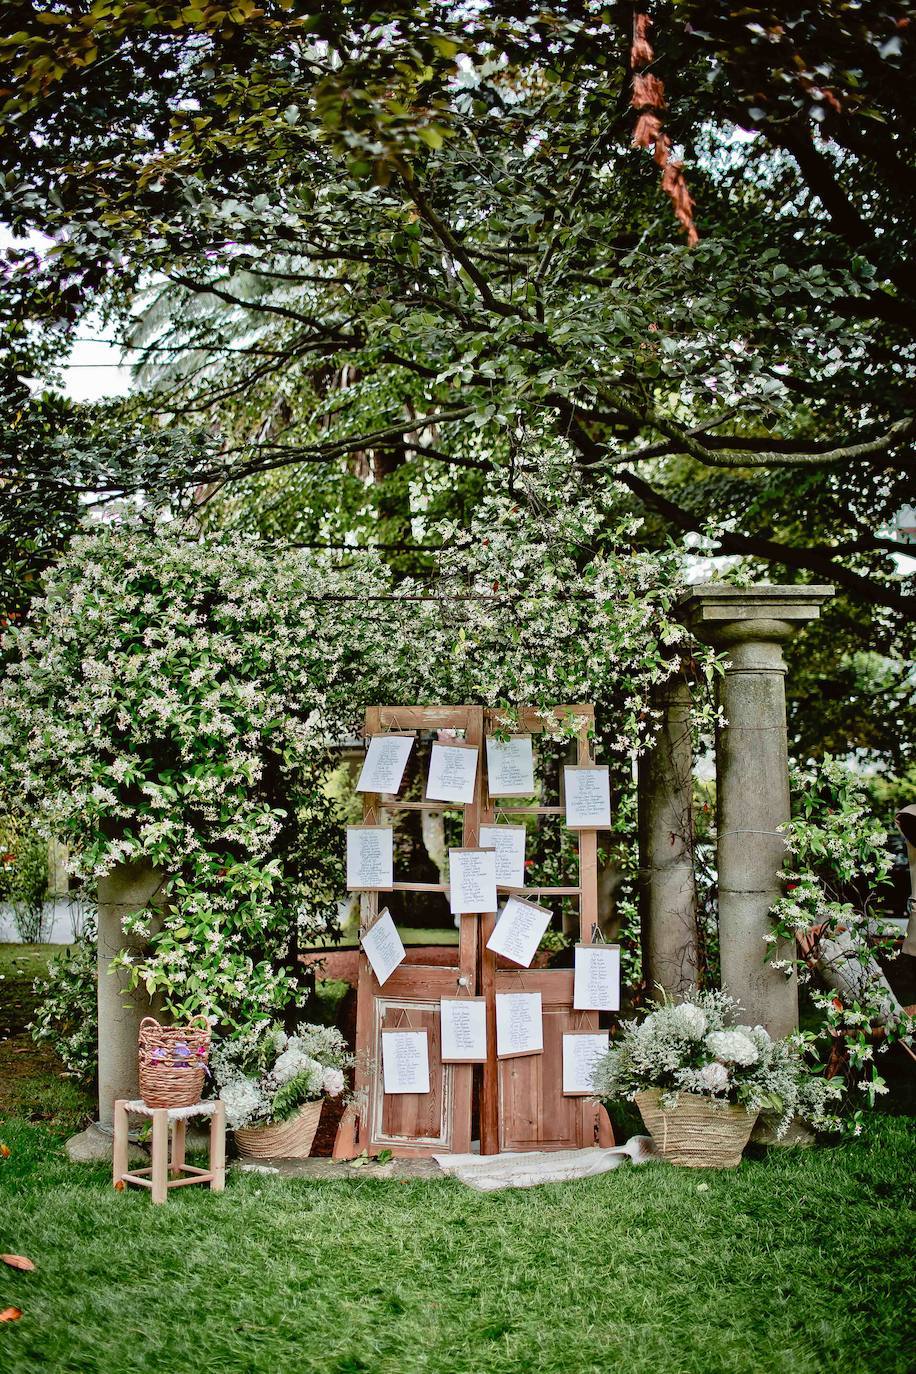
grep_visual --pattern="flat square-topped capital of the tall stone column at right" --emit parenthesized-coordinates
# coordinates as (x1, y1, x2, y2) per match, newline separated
(678, 583, 834, 672)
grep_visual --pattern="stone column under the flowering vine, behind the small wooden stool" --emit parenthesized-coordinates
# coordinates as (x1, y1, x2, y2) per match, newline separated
(98, 863, 163, 1128)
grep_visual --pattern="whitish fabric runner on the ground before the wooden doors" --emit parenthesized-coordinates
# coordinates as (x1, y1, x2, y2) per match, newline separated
(433, 1135, 658, 1193)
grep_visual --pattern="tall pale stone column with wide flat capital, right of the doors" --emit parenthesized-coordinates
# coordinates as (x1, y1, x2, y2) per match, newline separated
(683, 584, 834, 1036)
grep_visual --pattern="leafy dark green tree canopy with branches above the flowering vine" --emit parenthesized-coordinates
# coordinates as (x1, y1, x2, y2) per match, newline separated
(0, 0, 916, 763)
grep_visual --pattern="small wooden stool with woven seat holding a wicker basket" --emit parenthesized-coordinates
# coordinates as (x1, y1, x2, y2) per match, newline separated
(111, 1098, 225, 1202)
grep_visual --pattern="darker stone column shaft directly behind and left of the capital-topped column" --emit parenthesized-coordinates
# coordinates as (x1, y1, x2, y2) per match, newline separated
(639, 677, 699, 996)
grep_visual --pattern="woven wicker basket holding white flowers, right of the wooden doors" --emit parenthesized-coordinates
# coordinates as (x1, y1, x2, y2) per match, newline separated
(636, 1088, 758, 1169)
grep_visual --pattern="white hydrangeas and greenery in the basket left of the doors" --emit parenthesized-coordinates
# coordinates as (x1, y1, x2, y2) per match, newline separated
(210, 1021, 353, 1131)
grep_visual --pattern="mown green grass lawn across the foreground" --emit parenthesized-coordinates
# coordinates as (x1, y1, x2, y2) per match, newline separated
(0, 1117, 916, 1374)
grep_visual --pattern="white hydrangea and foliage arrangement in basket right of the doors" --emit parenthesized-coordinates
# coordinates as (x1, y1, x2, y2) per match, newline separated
(592, 991, 842, 1136)
